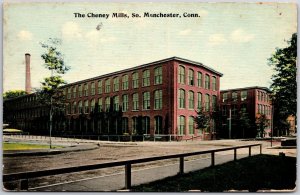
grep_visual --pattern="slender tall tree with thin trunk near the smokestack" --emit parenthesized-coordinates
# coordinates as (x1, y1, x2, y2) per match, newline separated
(38, 38, 70, 148)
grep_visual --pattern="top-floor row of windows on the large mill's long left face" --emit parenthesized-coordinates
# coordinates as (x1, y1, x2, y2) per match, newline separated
(66, 66, 162, 99)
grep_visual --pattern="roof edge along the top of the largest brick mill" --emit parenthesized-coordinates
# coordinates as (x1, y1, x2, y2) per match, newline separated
(63, 56, 223, 87)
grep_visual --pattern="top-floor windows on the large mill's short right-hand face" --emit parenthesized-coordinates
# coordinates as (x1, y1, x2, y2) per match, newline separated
(178, 65, 217, 91)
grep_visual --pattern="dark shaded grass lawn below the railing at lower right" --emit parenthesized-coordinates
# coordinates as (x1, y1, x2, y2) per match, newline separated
(132, 155, 297, 192)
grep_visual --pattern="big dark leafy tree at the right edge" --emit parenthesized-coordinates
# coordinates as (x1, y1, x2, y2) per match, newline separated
(269, 33, 297, 136)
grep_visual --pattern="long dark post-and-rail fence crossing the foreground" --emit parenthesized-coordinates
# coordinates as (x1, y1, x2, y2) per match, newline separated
(3, 144, 262, 190)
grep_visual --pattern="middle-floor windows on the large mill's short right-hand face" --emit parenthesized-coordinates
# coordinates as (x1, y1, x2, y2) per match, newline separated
(178, 89, 217, 111)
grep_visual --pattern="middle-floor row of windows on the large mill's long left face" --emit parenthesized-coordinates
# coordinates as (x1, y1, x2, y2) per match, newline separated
(67, 89, 162, 114)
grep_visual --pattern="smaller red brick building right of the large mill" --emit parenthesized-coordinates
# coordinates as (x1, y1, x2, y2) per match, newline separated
(220, 86, 272, 138)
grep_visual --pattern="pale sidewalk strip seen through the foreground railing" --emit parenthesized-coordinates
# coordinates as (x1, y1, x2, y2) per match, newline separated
(31, 149, 252, 191)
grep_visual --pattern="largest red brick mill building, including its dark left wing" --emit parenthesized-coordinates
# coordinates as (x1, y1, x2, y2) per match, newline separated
(4, 57, 222, 139)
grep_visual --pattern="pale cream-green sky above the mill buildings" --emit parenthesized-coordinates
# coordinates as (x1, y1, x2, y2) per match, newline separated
(3, 2, 297, 92)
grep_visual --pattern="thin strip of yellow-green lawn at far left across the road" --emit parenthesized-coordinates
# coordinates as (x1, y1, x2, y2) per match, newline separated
(2, 143, 62, 150)
